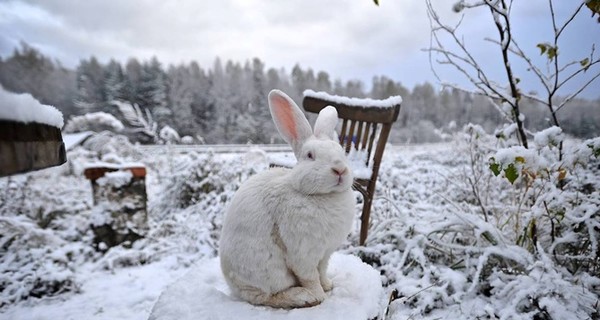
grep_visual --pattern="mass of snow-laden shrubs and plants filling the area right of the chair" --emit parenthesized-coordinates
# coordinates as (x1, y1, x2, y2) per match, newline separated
(345, 125, 600, 319)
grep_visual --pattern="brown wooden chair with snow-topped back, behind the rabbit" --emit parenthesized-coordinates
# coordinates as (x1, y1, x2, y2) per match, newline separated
(302, 90, 402, 245)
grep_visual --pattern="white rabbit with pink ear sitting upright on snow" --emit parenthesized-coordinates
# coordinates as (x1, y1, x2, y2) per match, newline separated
(219, 90, 356, 308)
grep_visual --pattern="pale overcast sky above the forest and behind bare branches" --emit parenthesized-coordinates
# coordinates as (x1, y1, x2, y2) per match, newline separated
(0, 0, 600, 98)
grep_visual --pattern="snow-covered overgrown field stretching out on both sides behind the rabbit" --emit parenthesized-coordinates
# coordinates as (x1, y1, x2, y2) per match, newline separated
(0, 134, 600, 320)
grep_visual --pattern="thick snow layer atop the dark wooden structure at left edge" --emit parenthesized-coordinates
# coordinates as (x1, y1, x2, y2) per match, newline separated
(0, 86, 64, 129)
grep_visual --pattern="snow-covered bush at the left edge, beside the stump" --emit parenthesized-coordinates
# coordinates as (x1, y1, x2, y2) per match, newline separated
(0, 160, 95, 309)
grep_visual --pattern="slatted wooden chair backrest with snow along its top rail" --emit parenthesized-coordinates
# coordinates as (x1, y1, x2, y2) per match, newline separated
(302, 91, 401, 176)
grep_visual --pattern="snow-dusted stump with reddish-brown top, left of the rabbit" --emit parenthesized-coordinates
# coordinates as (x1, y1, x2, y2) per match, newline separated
(84, 163, 148, 251)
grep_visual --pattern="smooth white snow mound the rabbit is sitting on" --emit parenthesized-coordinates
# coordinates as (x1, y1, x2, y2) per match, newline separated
(149, 253, 384, 320)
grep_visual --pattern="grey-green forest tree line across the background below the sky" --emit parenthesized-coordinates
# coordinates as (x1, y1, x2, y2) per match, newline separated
(0, 44, 600, 143)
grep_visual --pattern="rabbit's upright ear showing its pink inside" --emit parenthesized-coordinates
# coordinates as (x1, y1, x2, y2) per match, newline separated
(269, 90, 312, 159)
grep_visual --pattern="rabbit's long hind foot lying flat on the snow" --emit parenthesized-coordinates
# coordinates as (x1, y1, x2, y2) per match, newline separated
(237, 287, 323, 309)
